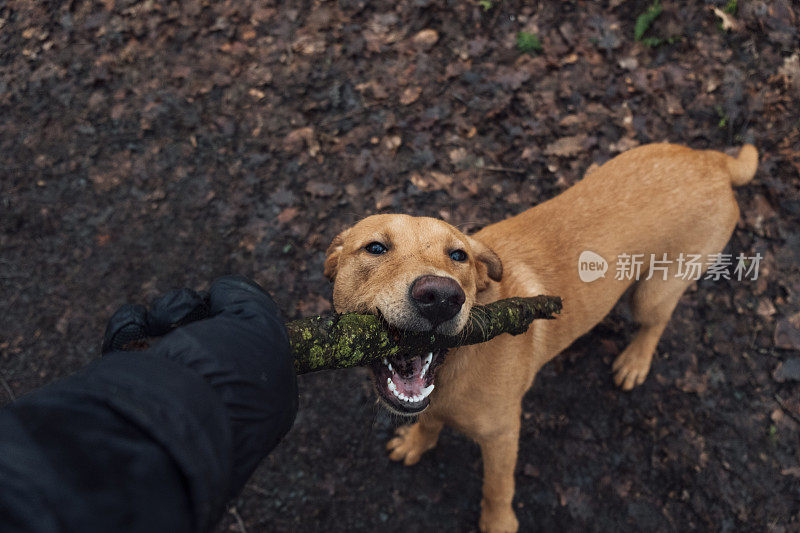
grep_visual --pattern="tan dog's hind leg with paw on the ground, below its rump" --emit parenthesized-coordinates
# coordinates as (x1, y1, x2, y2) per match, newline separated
(612, 272, 691, 390)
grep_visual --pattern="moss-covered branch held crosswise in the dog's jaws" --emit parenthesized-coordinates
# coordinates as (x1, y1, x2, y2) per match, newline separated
(286, 296, 561, 374)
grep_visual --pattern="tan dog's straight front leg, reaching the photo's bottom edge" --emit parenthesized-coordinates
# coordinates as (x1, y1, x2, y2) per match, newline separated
(478, 419, 520, 533)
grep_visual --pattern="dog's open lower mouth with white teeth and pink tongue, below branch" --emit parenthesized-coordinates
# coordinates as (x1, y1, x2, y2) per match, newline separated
(372, 350, 446, 416)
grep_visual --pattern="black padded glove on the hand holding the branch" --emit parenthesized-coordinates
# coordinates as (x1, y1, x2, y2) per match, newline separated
(102, 276, 297, 496)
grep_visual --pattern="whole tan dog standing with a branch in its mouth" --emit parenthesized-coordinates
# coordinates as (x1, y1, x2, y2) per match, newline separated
(325, 144, 758, 532)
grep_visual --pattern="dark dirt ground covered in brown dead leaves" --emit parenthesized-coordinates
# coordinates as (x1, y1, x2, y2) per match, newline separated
(0, 0, 800, 532)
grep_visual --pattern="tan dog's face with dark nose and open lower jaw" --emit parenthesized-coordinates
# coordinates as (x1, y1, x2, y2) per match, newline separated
(325, 215, 503, 415)
